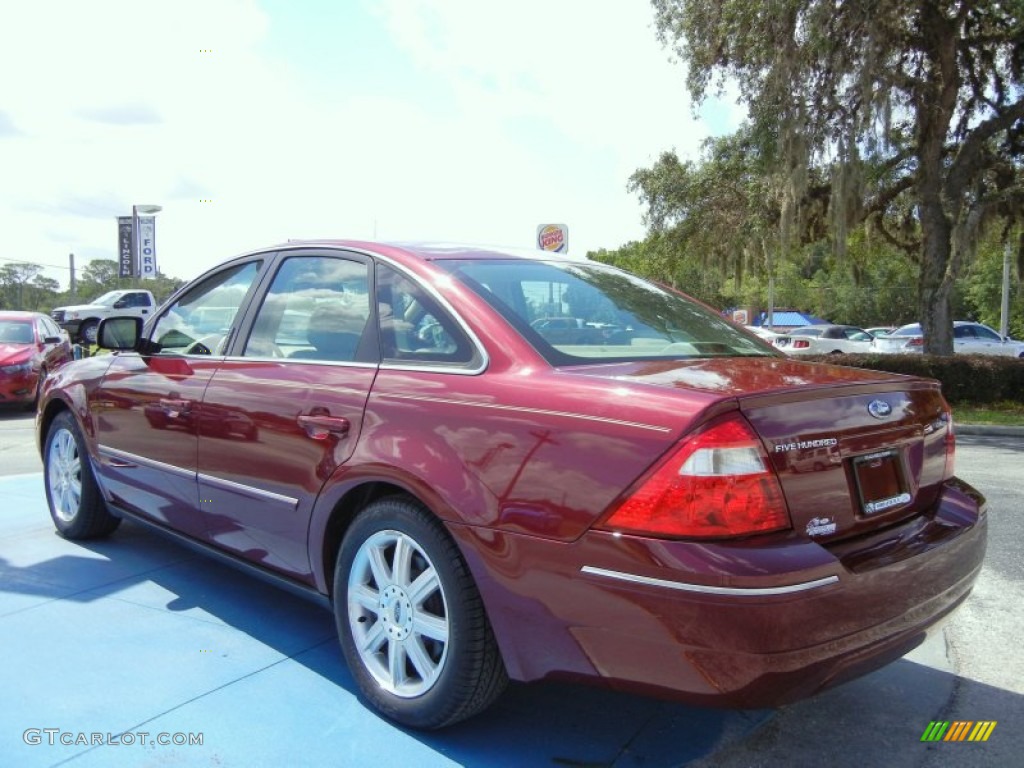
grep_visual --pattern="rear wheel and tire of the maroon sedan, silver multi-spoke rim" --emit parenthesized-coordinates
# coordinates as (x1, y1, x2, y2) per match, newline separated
(334, 497, 508, 729)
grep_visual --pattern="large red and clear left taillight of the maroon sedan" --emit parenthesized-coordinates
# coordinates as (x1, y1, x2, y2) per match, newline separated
(601, 415, 790, 538)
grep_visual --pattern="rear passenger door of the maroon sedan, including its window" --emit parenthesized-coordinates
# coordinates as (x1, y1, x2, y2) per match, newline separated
(197, 250, 379, 580)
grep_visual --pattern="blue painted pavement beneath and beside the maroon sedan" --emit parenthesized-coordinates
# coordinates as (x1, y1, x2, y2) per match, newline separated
(0, 473, 769, 768)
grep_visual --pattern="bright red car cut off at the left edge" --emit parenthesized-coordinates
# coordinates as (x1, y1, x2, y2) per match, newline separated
(0, 311, 73, 409)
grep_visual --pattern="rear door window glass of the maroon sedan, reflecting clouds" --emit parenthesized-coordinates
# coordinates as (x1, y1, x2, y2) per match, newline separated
(243, 256, 370, 362)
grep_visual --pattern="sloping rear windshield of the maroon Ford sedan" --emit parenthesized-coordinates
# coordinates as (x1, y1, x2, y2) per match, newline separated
(438, 260, 778, 366)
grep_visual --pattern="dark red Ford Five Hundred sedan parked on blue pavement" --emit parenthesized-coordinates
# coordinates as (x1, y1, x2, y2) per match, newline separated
(38, 242, 987, 728)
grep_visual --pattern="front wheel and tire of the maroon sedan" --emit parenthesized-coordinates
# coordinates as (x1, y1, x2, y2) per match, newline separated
(43, 411, 121, 540)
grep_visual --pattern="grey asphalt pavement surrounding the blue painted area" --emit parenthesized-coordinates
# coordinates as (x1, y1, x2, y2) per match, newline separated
(0, 411, 1024, 768)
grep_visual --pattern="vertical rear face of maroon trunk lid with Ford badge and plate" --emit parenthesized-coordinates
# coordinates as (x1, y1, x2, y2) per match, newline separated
(740, 383, 951, 541)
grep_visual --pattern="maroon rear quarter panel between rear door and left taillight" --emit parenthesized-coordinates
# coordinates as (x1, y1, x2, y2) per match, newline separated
(309, 366, 735, 586)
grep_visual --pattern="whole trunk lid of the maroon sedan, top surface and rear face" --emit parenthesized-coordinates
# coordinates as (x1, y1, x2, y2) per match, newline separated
(575, 357, 951, 542)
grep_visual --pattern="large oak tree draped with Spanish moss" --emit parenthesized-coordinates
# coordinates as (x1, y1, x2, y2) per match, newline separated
(652, 0, 1024, 354)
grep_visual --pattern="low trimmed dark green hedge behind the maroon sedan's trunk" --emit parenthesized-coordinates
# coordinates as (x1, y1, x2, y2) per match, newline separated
(799, 354, 1024, 406)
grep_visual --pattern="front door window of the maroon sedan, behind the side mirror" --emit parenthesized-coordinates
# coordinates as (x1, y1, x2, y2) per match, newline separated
(150, 261, 261, 354)
